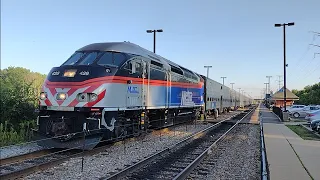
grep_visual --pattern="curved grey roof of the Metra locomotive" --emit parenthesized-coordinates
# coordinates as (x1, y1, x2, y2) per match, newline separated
(77, 42, 193, 72)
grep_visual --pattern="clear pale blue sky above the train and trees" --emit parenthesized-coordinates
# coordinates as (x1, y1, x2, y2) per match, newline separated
(1, 0, 320, 97)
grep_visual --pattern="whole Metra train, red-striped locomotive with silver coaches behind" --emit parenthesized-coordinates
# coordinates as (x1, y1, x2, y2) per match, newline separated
(35, 42, 252, 149)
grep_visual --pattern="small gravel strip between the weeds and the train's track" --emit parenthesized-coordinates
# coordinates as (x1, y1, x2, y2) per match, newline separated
(0, 143, 44, 159)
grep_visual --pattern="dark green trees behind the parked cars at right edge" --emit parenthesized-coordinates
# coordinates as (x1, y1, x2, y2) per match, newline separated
(292, 83, 320, 105)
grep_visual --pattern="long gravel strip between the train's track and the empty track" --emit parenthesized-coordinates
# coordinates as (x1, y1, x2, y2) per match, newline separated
(25, 112, 239, 180)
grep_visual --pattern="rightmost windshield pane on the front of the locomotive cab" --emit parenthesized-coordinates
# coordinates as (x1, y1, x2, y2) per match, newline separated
(97, 52, 126, 67)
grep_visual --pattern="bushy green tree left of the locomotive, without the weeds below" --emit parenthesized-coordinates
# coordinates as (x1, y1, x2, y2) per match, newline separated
(0, 67, 46, 129)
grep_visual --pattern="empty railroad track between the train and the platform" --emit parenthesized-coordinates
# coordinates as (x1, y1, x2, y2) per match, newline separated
(100, 108, 255, 180)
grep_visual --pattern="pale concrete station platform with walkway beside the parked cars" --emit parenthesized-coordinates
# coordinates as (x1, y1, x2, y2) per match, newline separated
(259, 105, 320, 180)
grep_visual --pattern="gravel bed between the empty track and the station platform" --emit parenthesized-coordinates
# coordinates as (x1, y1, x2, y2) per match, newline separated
(187, 124, 261, 180)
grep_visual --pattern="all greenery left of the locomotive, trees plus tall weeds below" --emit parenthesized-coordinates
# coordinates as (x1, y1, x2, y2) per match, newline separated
(0, 67, 46, 145)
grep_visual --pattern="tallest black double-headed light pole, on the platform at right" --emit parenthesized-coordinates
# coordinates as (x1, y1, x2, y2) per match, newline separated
(274, 22, 294, 112)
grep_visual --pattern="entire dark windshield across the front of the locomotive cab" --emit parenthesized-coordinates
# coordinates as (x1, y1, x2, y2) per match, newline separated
(62, 52, 131, 67)
